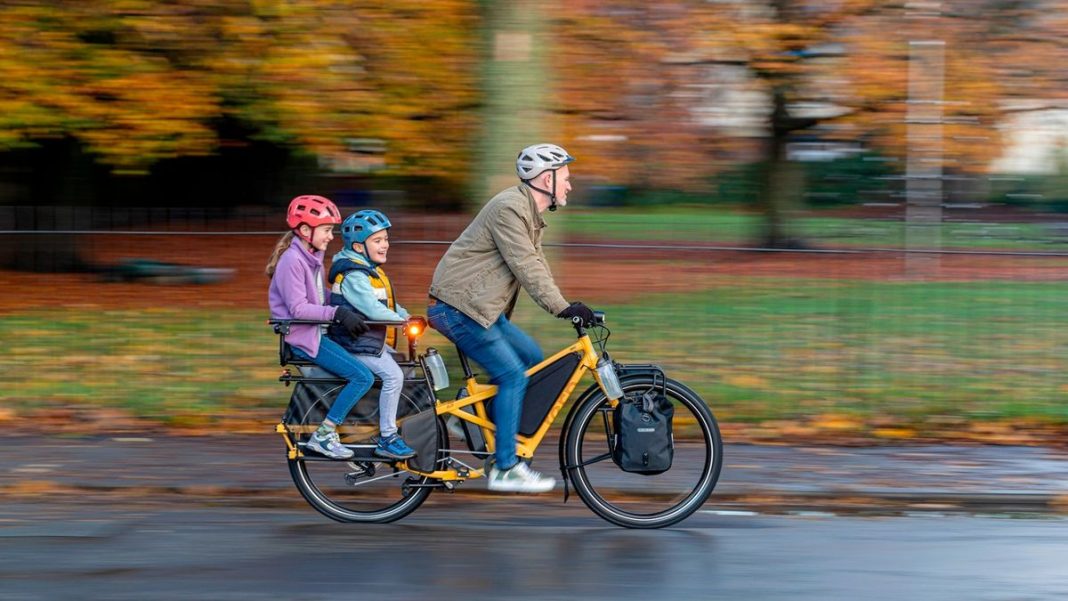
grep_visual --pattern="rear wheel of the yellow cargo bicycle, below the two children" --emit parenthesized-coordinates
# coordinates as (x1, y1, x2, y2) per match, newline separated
(286, 385, 447, 523)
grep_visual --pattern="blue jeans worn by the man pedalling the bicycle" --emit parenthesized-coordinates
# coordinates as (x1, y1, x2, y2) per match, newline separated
(426, 301, 543, 470)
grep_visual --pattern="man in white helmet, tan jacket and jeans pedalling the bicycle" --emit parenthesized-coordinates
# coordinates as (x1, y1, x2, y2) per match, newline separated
(427, 144, 594, 492)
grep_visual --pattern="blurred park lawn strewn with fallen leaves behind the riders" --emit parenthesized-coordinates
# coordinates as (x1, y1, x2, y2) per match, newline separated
(0, 208, 1068, 432)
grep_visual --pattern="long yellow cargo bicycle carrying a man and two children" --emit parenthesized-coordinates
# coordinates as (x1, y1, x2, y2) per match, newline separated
(270, 313, 723, 528)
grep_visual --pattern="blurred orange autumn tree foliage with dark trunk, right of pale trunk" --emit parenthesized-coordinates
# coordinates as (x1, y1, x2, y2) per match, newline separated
(553, 0, 1068, 247)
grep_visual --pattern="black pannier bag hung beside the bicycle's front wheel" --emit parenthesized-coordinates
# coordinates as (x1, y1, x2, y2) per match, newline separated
(612, 384, 675, 475)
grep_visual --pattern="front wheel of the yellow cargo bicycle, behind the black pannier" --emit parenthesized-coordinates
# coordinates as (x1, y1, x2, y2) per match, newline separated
(564, 377, 723, 528)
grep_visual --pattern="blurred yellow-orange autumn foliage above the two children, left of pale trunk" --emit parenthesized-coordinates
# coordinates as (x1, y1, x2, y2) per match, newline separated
(0, 0, 480, 183)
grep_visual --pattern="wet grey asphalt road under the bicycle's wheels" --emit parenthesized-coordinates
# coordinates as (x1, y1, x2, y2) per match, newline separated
(0, 495, 1068, 601)
